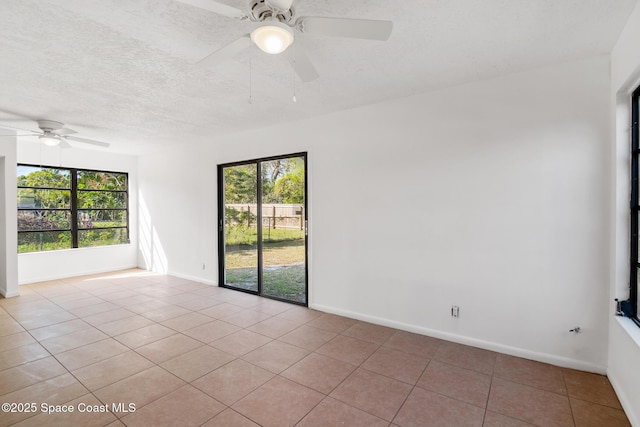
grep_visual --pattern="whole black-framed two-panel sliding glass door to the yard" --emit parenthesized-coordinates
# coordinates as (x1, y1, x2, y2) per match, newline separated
(218, 153, 307, 305)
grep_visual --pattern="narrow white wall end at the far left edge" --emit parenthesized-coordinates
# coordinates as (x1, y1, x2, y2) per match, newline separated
(0, 134, 18, 297)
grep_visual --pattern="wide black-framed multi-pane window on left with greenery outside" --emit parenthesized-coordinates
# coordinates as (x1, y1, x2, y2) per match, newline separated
(17, 165, 129, 253)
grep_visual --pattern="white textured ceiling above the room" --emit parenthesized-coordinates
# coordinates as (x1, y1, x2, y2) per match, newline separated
(0, 0, 637, 154)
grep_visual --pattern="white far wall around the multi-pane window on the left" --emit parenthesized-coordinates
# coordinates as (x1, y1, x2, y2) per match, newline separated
(13, 141, 138, 284)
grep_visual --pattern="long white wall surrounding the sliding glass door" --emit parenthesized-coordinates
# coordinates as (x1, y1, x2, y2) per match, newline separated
(139, 57, 609, 372)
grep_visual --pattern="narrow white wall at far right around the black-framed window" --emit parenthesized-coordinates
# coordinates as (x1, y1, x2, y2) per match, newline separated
(607, 4, 640, 426)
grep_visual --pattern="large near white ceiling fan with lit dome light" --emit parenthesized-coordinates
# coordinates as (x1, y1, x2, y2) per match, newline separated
(177, 0, 393, 82)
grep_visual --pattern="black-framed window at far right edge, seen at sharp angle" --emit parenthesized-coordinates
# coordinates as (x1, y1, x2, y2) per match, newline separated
(623, 87, 640, 326)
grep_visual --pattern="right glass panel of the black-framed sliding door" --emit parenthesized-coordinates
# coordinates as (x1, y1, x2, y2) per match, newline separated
(260, 157, 307, 304)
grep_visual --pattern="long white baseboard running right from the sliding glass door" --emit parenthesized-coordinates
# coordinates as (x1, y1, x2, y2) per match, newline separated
(309, 304, 607, 375)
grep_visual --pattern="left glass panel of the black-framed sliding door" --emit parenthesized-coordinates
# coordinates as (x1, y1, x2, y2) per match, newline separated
(223, 164, 259, 292)
